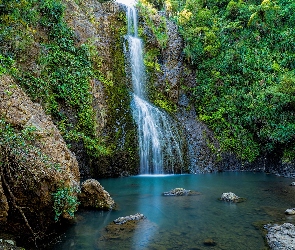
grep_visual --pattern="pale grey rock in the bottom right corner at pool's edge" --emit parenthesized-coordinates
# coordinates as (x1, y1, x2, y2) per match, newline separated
(264, 223, 295, 250)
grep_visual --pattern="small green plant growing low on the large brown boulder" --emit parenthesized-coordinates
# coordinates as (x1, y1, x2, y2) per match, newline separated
(52, 187, 79, 221)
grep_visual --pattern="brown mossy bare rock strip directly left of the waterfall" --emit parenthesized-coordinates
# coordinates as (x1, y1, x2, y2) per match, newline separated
(64, 0, 138, 179)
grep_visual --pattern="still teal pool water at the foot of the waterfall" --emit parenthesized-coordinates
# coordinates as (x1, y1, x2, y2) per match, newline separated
(55, 172, 295, 250)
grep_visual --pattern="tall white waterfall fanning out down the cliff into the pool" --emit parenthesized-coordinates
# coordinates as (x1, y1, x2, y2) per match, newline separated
(120, 0, 183, 174)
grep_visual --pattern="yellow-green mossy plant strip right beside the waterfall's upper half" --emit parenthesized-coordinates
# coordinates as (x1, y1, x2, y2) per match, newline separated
(137, 0, 182, 114)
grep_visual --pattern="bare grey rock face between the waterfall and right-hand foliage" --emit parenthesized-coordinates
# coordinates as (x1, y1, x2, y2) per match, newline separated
(144, 10, 222, 173)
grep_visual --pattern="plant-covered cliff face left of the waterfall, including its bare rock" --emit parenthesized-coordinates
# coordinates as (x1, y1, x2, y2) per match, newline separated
(0, 0, 141, 176)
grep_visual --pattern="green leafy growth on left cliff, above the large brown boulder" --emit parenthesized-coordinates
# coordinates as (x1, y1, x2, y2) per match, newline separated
(0, 0, 109, 157)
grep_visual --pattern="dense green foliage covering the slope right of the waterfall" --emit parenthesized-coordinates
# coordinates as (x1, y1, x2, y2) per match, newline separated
(143, 0, 295, 162)
